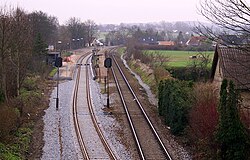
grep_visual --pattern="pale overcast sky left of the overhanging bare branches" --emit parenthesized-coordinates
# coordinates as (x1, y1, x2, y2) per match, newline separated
(0, 0, 204, 24)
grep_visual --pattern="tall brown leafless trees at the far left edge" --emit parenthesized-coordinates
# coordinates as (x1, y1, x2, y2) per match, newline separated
(0, 7, 33, 101)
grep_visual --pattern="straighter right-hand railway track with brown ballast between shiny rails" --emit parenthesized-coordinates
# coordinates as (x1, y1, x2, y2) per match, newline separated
(110, 49, 172, 160)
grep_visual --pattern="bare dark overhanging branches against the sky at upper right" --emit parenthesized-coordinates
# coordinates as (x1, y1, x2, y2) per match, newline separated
(196, 0, 250, 90)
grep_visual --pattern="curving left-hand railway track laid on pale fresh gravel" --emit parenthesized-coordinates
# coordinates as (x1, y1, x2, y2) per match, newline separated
(72, 53, 117, 160)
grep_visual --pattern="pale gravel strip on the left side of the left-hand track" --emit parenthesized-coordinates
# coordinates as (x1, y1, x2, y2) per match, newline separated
(42, 81, 78, 160)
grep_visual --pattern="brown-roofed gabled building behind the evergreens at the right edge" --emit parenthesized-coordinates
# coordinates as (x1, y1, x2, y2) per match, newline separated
(211, 45, 250, 90)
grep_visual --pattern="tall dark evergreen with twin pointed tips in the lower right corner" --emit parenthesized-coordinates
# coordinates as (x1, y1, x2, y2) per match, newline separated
(216, 79, 248, 160)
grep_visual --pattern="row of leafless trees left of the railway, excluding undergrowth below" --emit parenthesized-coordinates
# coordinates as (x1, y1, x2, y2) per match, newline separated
(0, 6, 97, 101)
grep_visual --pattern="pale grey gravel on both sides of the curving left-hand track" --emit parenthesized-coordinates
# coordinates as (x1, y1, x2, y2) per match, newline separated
(41, 65, 131, 160)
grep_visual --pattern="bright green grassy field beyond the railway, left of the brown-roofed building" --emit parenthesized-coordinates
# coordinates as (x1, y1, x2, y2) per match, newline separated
(145, 50, 214, 67)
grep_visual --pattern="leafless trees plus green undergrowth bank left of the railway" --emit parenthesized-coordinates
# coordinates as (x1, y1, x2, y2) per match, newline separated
(0, 6, 97, 159)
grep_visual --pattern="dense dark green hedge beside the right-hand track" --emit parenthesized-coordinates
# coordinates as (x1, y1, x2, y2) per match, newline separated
(158, 80, 193, 135)
